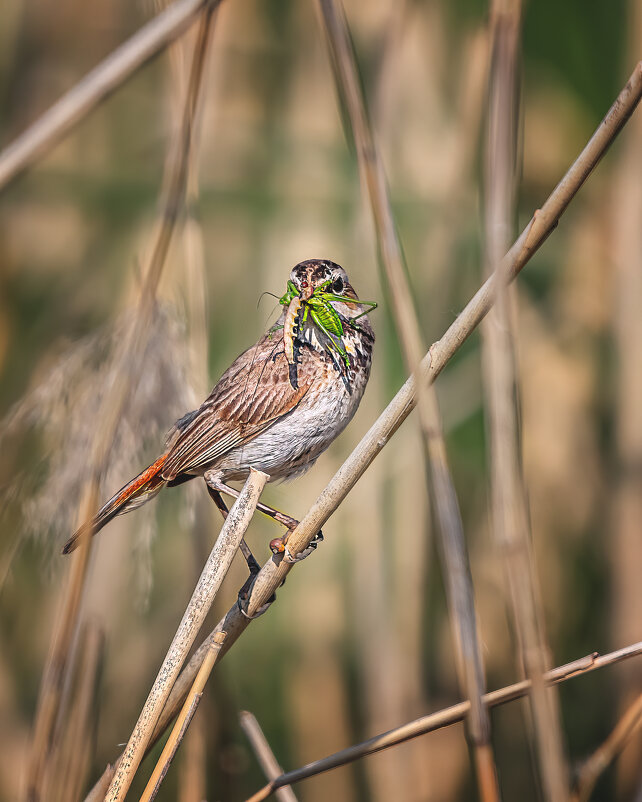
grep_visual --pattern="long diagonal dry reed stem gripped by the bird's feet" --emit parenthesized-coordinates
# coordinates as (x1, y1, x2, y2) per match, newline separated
(87, 61, 642, 800)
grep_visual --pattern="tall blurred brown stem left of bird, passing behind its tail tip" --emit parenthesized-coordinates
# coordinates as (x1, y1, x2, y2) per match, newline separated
(27, 11, 211, 800)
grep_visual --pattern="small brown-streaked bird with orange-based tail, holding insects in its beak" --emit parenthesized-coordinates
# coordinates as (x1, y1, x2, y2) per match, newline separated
(63, 259, 377, 560)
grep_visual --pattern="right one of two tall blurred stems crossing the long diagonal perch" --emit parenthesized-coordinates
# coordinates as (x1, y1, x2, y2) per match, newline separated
(483, 0, 568, 802)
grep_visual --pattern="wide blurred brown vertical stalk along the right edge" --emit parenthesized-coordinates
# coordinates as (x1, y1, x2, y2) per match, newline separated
(603, 0, 642, 799)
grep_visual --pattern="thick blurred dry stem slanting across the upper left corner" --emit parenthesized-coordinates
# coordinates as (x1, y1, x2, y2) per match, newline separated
(0, 0, 220, 191)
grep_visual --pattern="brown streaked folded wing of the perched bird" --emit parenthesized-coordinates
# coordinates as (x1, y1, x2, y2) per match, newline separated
(162, 335, 315, 481)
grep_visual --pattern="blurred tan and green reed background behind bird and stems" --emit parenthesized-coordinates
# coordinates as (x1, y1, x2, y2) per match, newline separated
(0, 0, 642, 802)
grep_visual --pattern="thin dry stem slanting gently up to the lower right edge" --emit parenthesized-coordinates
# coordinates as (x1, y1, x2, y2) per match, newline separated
(246, 641, 642, 802)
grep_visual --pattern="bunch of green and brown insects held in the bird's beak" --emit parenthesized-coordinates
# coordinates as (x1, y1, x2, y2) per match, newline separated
(279, 280, 377, 389)
